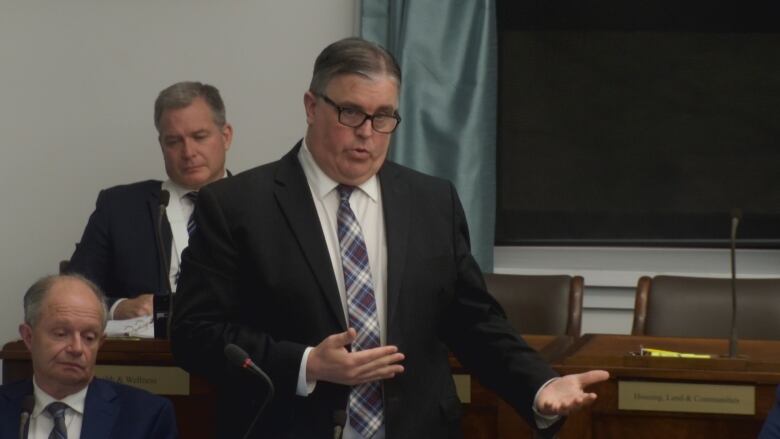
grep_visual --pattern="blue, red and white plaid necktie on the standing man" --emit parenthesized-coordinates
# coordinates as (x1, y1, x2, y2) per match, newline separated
(336, 185, 384, 439)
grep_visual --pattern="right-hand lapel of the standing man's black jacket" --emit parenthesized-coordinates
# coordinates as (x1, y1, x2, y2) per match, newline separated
(379, 162, 411, 336)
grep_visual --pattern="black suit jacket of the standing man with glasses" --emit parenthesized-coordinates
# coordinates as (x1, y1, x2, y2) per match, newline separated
(172, 146, 556, 439)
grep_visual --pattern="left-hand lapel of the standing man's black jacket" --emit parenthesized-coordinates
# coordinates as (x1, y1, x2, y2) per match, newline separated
(274, 142, 347, 330)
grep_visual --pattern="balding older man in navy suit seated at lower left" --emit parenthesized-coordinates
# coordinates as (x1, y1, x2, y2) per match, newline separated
(0, 275, 178, 439)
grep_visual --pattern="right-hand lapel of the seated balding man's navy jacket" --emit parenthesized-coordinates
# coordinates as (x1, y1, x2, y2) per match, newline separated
(81, 378, 119, 439)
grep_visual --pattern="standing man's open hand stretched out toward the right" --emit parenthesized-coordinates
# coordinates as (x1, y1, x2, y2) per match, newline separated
(536, 370, 609, 416)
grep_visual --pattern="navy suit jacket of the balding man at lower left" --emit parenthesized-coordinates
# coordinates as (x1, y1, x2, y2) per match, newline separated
(0, 378, 179, 439)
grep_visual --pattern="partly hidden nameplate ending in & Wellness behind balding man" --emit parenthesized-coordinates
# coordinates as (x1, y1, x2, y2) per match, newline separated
(95, 364, 190, 395)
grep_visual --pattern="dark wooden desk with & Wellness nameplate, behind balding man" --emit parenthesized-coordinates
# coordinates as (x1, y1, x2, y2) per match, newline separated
(0, 340, 216, 439)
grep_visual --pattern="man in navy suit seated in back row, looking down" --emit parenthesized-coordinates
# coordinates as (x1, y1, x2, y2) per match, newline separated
(68, 82, 233, 319)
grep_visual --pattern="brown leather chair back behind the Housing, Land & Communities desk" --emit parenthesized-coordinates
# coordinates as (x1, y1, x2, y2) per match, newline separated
(631, 276, 780, 340)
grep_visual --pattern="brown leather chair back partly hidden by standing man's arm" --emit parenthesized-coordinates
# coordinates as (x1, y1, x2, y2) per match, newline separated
(485, 273, 585, 337)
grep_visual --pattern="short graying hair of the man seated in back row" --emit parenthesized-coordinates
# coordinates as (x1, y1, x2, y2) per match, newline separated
(154, 81, 226, 132)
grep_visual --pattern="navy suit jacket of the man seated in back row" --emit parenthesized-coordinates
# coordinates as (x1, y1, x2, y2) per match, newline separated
(68, 180, 171, 303)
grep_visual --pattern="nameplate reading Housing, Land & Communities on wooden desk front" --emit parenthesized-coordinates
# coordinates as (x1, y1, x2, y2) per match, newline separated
(618, 381, 756, 415)
